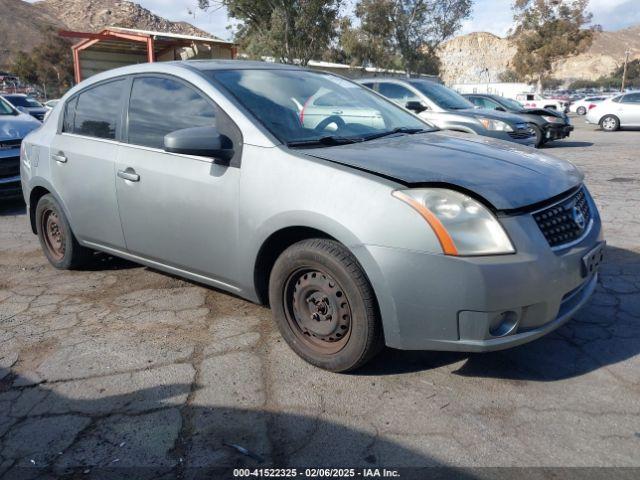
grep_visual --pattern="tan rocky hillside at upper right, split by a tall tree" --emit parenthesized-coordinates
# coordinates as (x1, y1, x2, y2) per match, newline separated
(439, 26, 640, 84)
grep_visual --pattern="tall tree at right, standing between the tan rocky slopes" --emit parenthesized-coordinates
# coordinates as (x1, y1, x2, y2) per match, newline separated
(512, 0, 599, 90)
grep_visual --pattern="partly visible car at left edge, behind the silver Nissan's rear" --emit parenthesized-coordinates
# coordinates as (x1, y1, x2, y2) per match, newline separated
(0, 97, 41, 199)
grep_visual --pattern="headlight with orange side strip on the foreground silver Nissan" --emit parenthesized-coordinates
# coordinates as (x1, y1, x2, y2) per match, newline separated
(393, 188, 515, 255)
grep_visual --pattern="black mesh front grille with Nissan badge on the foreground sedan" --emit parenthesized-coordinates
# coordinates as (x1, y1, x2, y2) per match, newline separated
(533, 188, 591, 247)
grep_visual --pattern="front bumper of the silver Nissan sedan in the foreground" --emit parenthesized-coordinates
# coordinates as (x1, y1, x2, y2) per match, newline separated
(354, 191, 602, 352)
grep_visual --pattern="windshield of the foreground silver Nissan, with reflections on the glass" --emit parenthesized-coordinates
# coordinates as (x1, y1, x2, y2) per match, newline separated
(205, 69, 430, 146)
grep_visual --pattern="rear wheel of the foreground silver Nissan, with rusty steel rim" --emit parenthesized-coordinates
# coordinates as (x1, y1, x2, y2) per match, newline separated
(36, 194, 92, 270)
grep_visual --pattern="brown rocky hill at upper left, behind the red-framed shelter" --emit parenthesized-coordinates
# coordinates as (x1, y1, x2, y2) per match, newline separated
(0, 0, 218, 66)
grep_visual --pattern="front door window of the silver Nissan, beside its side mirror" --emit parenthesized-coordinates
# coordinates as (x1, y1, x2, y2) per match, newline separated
(128, 77, 216, 148)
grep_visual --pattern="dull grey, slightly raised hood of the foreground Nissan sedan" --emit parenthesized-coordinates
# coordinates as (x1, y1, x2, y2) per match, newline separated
(304, 132, 583, 210)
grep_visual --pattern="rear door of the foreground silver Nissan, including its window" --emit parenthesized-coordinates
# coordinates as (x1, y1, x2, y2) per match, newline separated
(50, 79, 127, 248)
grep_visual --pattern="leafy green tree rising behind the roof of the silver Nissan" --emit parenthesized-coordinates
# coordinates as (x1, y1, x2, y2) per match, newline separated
(198, 0, 341, 65)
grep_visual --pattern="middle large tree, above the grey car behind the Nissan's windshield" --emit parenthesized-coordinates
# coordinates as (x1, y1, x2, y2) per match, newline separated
(340, 0, 472, 74)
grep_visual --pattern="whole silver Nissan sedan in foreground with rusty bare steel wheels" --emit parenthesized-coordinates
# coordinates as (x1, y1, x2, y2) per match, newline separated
(21, 60, 604, 371)
